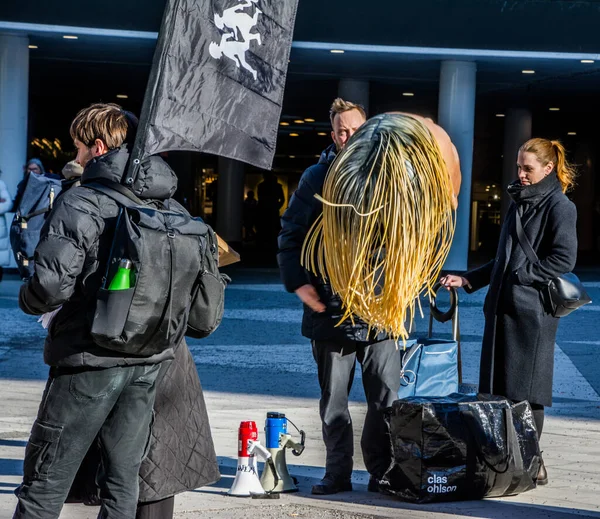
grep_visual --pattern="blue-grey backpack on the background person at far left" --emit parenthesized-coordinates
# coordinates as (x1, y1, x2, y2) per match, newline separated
(10, 173, 61, 279)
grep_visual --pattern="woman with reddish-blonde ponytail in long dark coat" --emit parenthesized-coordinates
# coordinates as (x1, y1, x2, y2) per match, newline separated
(440, 139, 577, 485)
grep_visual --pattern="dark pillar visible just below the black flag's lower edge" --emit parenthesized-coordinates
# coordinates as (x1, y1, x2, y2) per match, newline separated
(215, 157, 244, 243)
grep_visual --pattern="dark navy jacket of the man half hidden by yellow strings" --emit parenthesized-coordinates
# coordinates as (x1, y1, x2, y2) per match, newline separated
(277, 144, 385, 342)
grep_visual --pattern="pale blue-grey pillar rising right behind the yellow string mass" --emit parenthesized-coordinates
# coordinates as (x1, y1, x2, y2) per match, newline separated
(438, 61, 477, 271)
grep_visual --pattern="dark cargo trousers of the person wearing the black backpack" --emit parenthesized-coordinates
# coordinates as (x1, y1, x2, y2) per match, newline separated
(13, 364, 160, 519)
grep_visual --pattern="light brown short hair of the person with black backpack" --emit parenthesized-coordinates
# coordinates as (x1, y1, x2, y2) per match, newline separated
(70, 103, 128, 150)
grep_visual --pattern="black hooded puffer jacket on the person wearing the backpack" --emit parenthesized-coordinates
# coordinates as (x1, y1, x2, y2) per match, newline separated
(19, 146, 177, 367)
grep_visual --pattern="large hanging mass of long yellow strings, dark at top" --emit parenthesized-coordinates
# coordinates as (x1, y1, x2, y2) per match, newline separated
(302, 114, 455, 340)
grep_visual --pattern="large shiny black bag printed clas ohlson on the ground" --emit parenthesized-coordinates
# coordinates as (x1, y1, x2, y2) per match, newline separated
(381, 393, 541, 503)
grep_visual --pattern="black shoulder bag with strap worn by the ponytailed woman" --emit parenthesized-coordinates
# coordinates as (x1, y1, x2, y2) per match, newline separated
(515, 210, 592, 317)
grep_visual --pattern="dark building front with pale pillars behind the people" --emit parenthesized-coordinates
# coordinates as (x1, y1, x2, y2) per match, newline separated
(0, 0, 600, 270)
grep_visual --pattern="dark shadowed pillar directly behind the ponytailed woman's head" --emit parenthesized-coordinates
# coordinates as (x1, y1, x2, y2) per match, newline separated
(500, 108, 532, 220)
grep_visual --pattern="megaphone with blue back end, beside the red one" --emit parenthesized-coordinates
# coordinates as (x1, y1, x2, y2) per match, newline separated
(260, 412, 306, 493)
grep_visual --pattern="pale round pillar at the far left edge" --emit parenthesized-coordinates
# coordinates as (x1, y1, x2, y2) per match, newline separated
(0, 34, 29, 197)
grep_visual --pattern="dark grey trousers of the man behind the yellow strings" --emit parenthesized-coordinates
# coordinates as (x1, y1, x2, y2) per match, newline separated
(313, 340, 400, 479)
